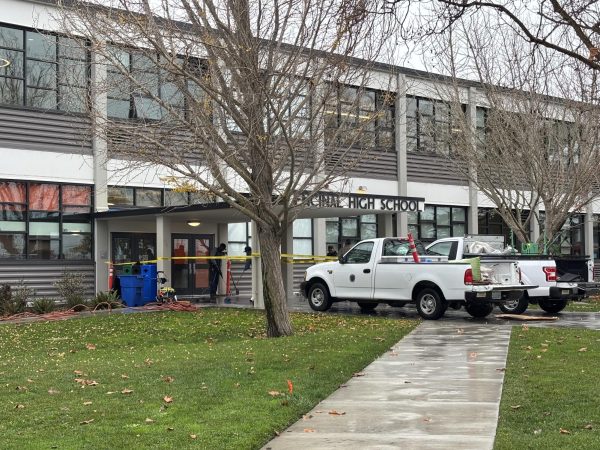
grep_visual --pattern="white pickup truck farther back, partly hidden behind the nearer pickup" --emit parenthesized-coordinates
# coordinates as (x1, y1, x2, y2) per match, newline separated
(427, 235, 598, 314)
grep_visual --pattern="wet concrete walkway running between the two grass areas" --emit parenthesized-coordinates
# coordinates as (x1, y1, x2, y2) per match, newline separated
(264, 321, 511, 450)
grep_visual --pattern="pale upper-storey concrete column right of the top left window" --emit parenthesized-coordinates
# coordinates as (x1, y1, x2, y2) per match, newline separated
(91, 42, 108, 211)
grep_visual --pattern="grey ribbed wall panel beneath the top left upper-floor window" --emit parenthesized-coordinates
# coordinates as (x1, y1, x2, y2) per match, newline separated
(0, 108, 92, 154)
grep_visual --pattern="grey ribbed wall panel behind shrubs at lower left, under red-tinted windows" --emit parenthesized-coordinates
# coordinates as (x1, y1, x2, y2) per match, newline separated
(0, 261, 95, 298)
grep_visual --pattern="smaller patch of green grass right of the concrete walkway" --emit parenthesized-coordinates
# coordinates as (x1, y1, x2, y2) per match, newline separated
(495, 325, 600, 449)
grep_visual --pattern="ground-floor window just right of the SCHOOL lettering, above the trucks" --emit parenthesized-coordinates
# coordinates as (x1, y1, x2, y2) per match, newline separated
(408, 205, 467, 242)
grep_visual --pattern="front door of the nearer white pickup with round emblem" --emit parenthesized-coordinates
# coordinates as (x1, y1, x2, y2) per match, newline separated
(333, 241, 374, 299)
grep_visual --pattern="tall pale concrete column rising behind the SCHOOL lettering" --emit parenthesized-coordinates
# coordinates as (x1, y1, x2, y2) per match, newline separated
(390, 74, 410, 236)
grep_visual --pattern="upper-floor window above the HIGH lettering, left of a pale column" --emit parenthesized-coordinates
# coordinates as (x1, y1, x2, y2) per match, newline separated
(325, 86, 395, 149)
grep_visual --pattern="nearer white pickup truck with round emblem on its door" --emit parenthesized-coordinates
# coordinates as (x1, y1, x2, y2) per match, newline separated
(300, 238, 535, 320)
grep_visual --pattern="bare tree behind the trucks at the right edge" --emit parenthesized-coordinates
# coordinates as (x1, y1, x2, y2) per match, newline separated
(424, 21, 600, 250)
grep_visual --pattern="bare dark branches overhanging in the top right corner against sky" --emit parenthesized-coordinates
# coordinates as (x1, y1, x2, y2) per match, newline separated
(385, 0, 600, 70)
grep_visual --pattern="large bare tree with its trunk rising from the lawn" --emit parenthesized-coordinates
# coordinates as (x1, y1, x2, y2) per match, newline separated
(54, 0, 393, 336)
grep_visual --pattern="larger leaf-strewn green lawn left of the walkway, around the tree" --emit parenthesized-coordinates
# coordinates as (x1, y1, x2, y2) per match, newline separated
(0, 308, 418, 449)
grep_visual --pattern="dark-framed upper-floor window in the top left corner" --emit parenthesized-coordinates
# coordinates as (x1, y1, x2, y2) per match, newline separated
(0, 26, 89, 113)
